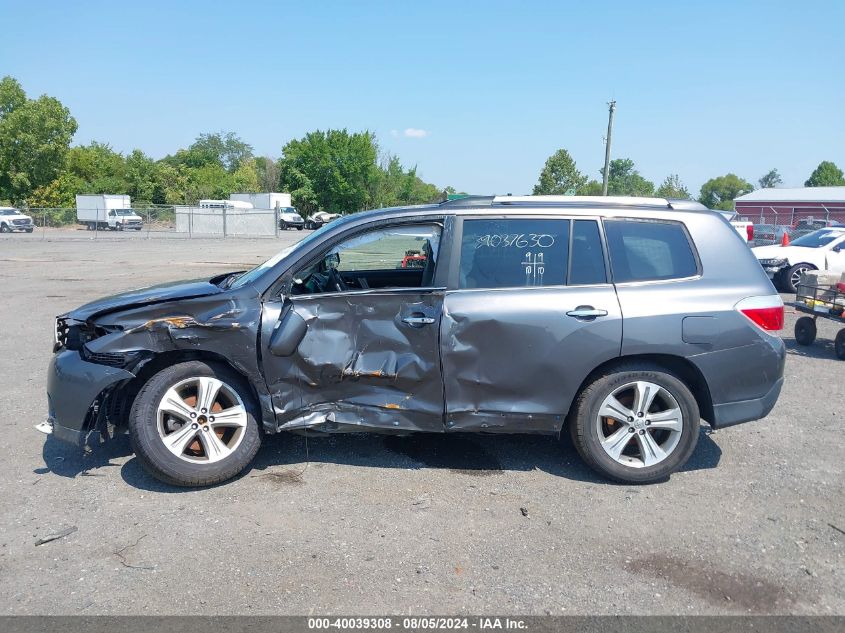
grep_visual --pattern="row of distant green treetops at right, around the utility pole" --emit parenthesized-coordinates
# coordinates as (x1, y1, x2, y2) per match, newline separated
(533, 149, 845, 210)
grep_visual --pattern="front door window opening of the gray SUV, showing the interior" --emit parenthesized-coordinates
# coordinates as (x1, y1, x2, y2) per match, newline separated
(291, 224, 441, 295)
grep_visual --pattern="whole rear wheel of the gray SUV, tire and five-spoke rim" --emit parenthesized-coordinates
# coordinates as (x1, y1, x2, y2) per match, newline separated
(569, 366, 699, 483)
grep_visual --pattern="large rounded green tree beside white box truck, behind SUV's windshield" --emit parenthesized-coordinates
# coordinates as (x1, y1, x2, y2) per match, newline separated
(280, 130, 378, 213)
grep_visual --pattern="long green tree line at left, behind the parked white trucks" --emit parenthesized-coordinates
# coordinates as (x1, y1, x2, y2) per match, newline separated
(0, 77, 454, 220)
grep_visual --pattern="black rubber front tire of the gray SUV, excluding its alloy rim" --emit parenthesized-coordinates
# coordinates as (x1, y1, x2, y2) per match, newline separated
(129, 361, 261, 486)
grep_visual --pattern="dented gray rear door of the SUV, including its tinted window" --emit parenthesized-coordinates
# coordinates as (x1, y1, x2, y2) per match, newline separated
(441, 215, 622, 433)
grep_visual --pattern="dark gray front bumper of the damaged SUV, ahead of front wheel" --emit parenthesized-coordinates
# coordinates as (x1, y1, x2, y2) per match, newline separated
(47, 350, 135, 446)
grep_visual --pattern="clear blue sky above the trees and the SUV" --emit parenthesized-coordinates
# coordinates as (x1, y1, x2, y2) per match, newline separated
(0, 0, 845, 194)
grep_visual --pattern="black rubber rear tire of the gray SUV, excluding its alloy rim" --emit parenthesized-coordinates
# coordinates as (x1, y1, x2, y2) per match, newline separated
(568, 364, 699, 484)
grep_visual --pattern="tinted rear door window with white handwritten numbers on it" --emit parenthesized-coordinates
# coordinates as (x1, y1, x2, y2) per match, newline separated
(459, 218, 569, 288)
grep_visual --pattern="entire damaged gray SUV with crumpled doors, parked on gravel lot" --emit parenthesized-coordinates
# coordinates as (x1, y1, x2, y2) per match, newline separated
(44, 196, 785, 486)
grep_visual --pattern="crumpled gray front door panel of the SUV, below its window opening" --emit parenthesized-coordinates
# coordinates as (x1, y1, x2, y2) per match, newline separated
(262, 289, 443, 431)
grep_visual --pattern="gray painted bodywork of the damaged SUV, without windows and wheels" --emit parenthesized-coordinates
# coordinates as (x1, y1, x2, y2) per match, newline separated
(48, 199, 785, 446)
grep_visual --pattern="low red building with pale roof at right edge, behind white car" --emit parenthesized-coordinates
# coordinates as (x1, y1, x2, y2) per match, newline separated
(734, 187, 845, 227)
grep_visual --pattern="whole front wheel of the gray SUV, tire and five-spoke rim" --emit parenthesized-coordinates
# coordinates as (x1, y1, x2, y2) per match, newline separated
(129, 361, 261, 486)
